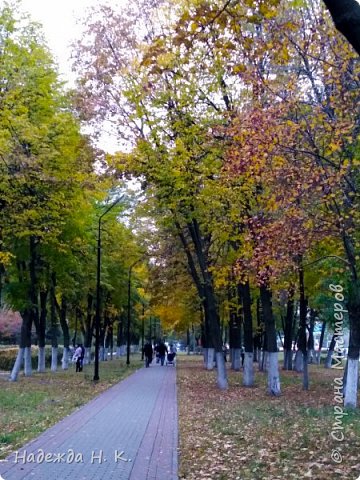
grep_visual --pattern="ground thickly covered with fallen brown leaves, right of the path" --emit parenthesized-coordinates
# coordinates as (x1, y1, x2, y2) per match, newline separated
(178, 356, 360, 480)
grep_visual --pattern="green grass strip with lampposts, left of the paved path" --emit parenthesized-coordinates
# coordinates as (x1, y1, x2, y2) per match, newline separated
(0, 355, 143, 458)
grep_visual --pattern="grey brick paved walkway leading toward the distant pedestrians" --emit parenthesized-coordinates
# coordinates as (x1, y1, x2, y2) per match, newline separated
(0, 363, 178, 480)
